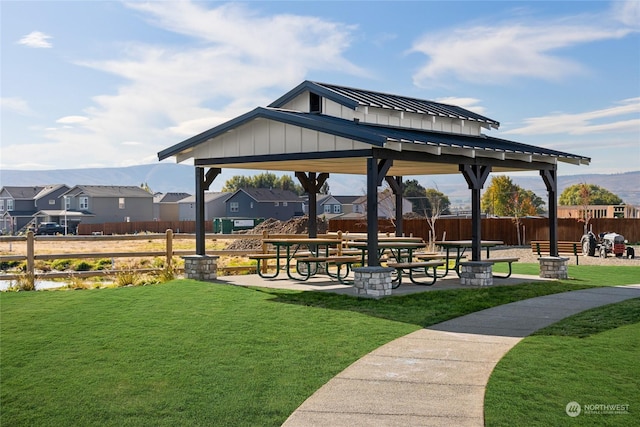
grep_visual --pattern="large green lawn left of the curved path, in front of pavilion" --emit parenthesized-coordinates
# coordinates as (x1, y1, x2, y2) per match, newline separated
(0, 265, 640, 426)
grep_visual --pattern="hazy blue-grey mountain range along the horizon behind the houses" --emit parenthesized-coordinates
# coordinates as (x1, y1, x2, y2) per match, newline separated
(0, 163, 640, 207)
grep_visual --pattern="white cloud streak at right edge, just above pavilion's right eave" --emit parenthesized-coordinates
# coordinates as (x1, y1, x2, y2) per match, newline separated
(504, 98, 640, 135)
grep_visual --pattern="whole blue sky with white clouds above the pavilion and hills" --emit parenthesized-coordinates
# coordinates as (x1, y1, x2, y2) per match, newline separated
(0, 0, 640, 190)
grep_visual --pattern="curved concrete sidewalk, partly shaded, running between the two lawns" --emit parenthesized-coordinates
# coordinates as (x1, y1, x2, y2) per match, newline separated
(283, 285, 640, 427)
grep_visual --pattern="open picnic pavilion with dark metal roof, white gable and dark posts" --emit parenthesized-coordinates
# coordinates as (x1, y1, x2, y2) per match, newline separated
(158, 81, 590, 292)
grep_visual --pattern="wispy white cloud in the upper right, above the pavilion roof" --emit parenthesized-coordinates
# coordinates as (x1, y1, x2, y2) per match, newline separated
(411, 2, 637, 86)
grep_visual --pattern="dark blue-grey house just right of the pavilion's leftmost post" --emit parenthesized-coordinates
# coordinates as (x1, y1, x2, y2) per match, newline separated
(225, 188, 304, 221)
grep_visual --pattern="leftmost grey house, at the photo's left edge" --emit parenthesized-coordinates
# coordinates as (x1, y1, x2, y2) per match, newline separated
(0, 184, 69, 234)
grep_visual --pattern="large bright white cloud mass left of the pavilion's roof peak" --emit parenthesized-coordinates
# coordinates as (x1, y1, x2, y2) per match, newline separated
(24, 2, 366, 171)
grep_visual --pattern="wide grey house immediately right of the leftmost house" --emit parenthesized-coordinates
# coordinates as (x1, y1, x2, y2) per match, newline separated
(62, 185, 154, 224)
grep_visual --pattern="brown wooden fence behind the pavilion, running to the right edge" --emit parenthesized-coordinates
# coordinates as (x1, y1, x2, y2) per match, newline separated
(329, 218, 640, 245)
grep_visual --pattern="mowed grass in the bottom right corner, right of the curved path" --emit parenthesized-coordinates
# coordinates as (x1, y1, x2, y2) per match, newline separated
(485, 299, 640, 427)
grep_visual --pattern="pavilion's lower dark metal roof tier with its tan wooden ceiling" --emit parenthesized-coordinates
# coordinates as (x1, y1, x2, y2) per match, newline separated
(158, 107, 590, 176)
